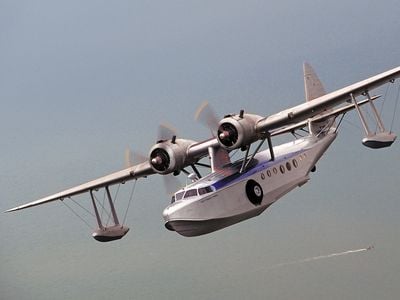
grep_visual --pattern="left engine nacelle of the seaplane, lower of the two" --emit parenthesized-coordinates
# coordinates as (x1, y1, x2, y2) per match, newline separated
(149, 139, 195, 174)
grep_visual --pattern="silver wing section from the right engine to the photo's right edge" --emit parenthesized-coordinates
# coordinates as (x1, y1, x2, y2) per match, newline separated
(257, 67, 400, 132)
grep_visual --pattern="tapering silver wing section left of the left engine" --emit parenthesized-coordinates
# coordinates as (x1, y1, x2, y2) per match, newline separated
(6, 161, 154, 212)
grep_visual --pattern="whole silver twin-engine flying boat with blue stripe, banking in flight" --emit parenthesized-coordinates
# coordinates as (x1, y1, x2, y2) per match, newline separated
(6, 63, 400, 242)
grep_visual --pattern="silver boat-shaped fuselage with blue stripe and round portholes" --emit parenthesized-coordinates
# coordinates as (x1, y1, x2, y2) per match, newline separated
(163, 128, 337, 236)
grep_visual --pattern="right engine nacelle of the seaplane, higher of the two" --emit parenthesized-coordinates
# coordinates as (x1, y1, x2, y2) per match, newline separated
(217, 112, 263, 150)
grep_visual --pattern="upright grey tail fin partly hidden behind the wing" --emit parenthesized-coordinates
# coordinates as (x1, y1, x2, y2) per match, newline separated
(303, 62, 334, 135)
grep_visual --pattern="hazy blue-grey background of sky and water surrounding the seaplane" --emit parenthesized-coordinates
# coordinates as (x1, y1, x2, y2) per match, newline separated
(0, 0, 400, 299)
